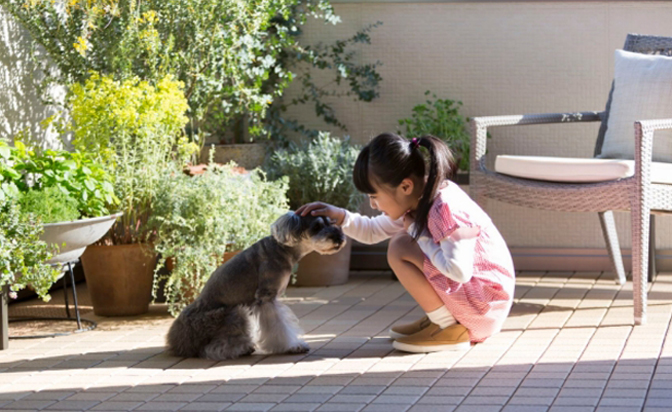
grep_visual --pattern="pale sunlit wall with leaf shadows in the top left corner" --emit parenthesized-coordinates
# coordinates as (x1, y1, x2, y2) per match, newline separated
(0, 7, 63, 147)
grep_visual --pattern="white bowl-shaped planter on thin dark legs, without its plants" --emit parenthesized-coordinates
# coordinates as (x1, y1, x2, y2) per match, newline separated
(40, 213, 123, 264)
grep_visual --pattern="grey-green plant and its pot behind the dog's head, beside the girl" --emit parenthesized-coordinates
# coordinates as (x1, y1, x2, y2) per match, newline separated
(267, 133, 363, 286)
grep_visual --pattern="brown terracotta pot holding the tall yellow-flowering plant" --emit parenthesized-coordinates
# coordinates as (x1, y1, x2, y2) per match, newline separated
(82, 244, 156, 316)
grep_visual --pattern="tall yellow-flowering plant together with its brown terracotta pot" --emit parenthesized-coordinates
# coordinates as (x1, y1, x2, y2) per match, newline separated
(69, 73, 195, 316)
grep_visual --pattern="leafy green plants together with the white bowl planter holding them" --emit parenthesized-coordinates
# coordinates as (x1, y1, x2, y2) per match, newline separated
(5, 140, 119, 264)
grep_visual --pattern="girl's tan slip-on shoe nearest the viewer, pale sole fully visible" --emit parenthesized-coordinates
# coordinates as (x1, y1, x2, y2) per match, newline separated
(392, 323, 471, 353)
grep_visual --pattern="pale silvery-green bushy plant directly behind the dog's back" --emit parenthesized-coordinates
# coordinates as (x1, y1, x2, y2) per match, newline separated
(148, 163, 288, 316)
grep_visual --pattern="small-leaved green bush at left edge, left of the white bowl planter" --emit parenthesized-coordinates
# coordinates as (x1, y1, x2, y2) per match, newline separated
(0, 198, 61, 301)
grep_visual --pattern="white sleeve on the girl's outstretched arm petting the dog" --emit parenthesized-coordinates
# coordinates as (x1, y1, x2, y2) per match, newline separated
(341, 210, 404, 244)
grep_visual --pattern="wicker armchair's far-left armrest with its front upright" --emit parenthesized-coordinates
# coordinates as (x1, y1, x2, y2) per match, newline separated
(470, 112, 604, 171)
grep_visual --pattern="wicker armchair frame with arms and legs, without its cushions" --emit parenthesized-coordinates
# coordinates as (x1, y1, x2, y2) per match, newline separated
(470, 34, 672, 325)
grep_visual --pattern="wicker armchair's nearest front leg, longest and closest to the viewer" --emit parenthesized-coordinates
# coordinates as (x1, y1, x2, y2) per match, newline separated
(631, 201, 651, 325)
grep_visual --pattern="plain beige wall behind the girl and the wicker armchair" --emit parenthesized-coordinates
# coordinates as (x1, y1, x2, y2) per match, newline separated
(289, 1, 672, 249)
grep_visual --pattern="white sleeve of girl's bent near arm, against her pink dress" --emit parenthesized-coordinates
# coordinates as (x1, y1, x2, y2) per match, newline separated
(418, 232, 477, 283)
